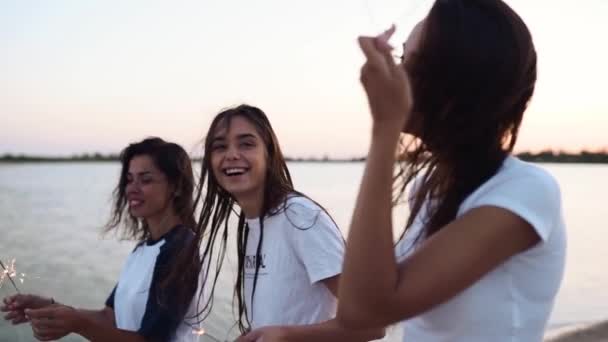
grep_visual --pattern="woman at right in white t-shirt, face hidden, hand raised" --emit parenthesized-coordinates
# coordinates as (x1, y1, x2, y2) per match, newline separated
(334, 0, 566, 342)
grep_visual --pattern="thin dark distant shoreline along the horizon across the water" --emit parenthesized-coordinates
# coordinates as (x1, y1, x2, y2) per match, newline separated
(0, 150, 608, 164)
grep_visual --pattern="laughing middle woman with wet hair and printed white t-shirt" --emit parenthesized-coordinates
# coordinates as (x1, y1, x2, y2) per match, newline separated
(198, 105, 383, 342)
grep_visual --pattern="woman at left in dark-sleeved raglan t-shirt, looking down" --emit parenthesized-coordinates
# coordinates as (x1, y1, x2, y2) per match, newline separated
(2, 138, 200, 342)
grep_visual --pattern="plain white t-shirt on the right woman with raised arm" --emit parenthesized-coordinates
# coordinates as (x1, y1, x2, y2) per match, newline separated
(397, 157, 566, 342)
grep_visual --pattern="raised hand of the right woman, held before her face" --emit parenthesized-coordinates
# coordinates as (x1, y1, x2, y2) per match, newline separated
(359, 25, 413, 130)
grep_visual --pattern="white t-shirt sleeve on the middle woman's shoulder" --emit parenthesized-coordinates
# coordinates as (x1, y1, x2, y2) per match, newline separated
(286, 202, 344, 284)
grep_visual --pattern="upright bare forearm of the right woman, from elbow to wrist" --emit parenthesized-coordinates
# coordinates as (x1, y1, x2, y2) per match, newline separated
(337, 124, 399, 328)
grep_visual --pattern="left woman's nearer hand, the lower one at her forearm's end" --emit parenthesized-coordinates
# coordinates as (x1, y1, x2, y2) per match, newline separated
(25, 304, 79, 341)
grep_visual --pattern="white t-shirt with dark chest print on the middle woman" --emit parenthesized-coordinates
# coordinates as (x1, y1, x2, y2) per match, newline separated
(244, 196, 344, 329)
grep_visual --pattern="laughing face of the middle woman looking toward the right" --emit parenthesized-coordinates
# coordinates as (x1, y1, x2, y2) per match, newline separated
(211, 115, 267, 202)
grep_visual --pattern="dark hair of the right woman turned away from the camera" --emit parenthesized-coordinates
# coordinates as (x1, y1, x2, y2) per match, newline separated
(395, 0, 536, 237)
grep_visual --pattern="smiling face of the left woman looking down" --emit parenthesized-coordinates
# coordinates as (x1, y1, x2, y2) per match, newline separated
(126, 155, 172, 220)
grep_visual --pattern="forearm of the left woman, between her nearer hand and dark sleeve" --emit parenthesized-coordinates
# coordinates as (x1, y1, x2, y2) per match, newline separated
(75, 309, 146, 342)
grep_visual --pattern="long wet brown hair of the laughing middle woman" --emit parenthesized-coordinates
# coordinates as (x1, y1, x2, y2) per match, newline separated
(196, 104, 303, 332)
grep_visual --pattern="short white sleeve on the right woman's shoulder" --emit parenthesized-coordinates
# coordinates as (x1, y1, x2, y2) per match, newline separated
(465, 170, 561, 241)
